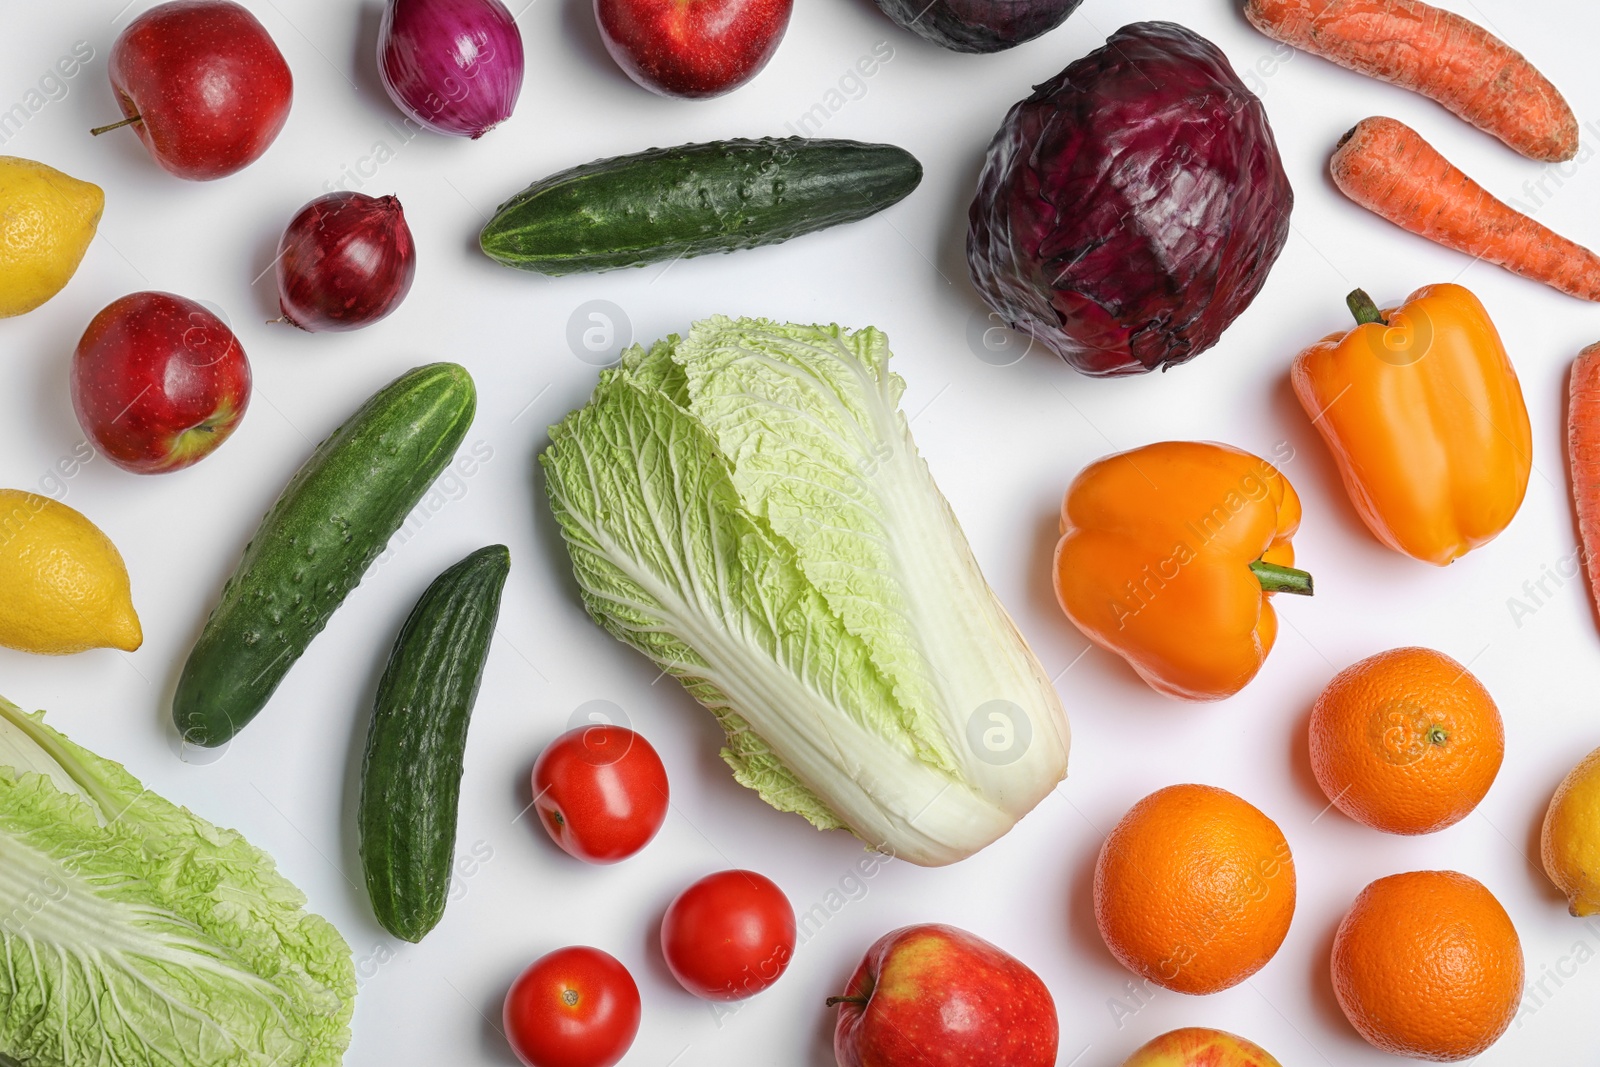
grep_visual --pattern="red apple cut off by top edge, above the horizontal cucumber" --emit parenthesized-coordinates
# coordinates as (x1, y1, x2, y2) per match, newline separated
(595, 0, 794, 98)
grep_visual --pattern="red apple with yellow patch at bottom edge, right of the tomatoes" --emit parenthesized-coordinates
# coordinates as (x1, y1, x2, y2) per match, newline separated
(827, 925, 1059, 1067)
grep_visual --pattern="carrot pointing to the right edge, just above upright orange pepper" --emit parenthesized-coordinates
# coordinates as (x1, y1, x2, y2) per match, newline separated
(1333, 117, 1600, 301)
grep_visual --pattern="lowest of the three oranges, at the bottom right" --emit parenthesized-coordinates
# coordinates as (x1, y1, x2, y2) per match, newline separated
(1333, 870, 1522, 1062)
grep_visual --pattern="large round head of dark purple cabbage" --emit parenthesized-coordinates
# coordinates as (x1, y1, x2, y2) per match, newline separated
(966, 22, 1294, 376)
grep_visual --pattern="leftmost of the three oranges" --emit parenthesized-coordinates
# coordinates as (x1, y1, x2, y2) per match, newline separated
(1094, 785, 1294, 993)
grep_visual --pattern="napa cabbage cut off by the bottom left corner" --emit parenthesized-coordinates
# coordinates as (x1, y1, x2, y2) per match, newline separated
(0, 699, 355, 1067)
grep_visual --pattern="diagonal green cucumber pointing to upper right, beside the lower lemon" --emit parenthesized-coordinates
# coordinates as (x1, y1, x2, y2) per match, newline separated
(173, 363, 477, 747)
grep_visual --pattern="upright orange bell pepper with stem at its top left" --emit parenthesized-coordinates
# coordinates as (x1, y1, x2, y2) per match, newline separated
(1291, 285, 1533, 566)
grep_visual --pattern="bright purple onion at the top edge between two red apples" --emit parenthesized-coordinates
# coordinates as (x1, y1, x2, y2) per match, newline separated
(378, 0, 522, 139)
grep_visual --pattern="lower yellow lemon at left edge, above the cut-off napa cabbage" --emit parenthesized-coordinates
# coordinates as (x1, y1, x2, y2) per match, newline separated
(0, 490, 144, 656)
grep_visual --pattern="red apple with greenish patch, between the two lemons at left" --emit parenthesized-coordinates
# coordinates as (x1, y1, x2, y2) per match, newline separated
(72, 293, 250, 474)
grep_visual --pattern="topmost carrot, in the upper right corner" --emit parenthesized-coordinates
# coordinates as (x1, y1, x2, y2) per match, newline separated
(1245, 0, 1578, 163)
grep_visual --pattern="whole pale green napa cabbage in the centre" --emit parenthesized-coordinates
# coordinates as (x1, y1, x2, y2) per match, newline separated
(539, 317, 1069, 865)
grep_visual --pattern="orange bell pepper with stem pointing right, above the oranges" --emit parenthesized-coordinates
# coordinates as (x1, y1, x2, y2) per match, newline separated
(1054, 442, 1312, 701)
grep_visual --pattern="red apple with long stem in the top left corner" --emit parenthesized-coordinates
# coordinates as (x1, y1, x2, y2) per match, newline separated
(94, 0, 294, 181)
